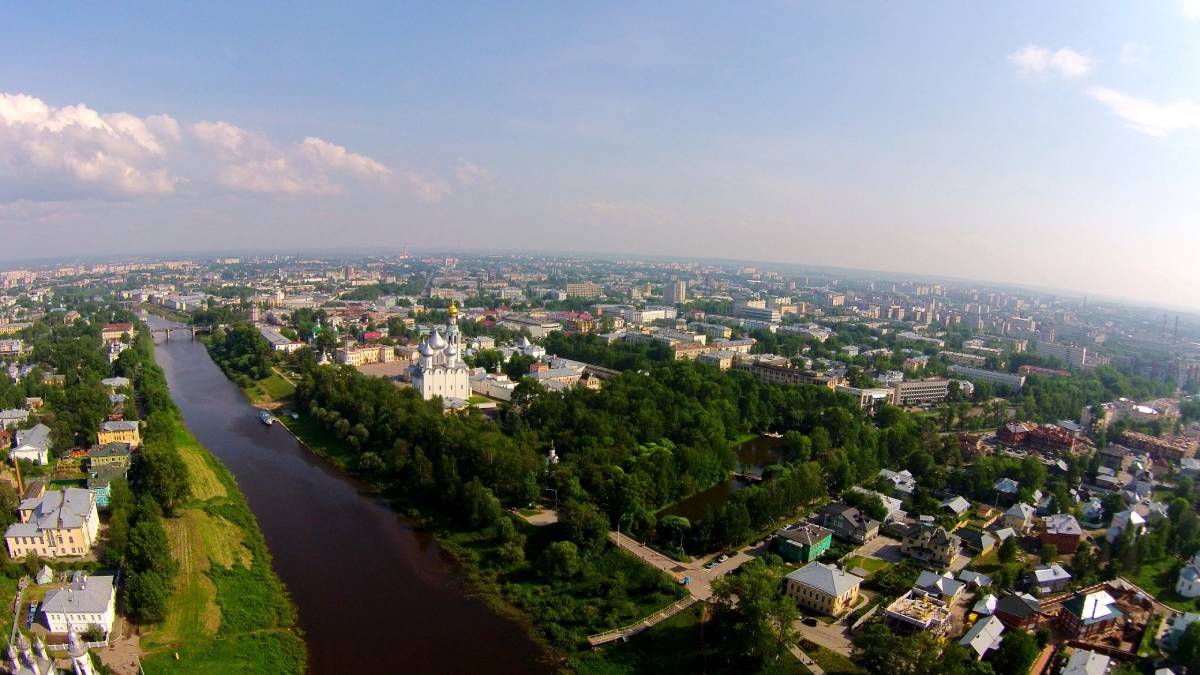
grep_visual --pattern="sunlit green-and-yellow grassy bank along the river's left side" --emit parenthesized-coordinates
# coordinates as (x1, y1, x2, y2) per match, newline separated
(142, 365, 306, 675)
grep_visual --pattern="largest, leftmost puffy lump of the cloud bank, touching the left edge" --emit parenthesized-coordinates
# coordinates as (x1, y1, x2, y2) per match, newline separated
(0, 92, 180, 196)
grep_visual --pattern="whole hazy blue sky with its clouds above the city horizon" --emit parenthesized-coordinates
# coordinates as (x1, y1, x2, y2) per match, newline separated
(0, 0, 1200, 306)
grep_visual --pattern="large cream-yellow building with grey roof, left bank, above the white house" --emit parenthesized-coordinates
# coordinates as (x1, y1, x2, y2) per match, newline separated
(5, 488, 100, 560)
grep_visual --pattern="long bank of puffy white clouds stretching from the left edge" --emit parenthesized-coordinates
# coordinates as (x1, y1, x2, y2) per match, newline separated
(0, 92, 451, 203)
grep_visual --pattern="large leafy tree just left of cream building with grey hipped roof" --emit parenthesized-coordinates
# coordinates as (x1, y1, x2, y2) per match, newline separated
(713, 560, 799, 663)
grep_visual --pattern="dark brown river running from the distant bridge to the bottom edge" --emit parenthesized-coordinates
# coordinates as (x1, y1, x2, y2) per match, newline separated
(146, 316, 553, 675)
